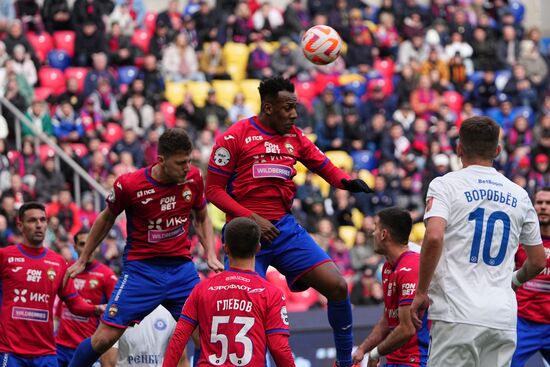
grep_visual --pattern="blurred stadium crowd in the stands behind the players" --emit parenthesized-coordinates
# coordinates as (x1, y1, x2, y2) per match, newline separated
(0, 0, 550, 310)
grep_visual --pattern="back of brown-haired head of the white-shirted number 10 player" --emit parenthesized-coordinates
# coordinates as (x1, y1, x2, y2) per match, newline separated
(457, 116, 501, 161)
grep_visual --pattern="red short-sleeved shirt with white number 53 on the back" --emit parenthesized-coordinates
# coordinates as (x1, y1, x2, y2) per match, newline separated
(180, 269, 289, 366)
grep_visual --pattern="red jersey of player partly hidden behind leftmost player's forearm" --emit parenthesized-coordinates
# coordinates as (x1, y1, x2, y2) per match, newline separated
(55, 261, 117, 348)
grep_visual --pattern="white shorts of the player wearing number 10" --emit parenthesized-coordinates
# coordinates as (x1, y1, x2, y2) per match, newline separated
(428, 320, 516, 367)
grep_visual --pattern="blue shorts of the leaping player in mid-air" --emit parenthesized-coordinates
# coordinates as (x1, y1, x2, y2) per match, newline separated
(225, 214, 332, 292)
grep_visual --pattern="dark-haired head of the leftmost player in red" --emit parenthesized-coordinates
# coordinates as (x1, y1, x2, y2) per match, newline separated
(17, 201, 48, 246)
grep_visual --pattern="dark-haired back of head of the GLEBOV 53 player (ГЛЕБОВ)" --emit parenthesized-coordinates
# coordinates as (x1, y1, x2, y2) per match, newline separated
(223, 217, 261, 259)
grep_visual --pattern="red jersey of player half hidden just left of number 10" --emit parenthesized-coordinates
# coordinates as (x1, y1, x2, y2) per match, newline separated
(382, 251, 430, 367)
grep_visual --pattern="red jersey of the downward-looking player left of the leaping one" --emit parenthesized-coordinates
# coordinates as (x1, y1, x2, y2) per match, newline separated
(107, 166, 206, 260)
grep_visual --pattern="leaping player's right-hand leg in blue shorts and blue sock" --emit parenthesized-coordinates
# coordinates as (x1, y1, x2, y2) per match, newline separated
(271, 215, 353, 367)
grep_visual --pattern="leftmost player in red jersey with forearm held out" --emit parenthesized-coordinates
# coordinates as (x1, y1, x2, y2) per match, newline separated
(0, 202, 105, 367)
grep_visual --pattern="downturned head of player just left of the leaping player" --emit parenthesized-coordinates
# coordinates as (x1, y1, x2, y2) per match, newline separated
(158, 128, 193, 183)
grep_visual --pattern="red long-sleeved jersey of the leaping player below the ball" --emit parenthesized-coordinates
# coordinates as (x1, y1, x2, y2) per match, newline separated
(208, 117, 347, 220)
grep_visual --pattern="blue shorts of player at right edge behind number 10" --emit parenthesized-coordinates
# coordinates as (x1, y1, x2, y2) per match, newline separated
(512, 316, 550, 367)
